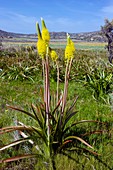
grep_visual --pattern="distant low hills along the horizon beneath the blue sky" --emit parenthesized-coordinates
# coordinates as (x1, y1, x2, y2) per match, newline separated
(0, 30, 106, 42)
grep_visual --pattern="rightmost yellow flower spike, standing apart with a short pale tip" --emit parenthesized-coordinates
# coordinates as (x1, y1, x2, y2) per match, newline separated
(65, 34, 75, 60)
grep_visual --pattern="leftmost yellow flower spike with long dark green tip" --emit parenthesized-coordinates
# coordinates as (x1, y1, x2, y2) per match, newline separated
(36, 22, 47, 58)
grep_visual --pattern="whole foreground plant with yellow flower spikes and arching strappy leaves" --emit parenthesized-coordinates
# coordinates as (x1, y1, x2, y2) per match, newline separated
(0, 18, 106, 170)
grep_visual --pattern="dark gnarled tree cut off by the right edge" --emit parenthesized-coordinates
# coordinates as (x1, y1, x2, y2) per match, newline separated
(101, 19, 113, 63)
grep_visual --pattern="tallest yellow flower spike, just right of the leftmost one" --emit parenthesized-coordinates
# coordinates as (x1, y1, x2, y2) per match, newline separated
(41, 18, 50, 45)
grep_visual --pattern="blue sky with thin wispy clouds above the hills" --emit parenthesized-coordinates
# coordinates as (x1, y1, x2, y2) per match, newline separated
(0, 0, 113, 33)
